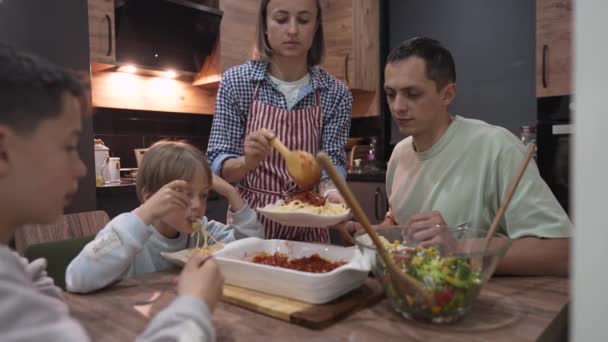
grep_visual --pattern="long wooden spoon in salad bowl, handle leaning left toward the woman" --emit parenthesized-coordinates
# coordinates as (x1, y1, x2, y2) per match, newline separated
(317, 152, 434, 307)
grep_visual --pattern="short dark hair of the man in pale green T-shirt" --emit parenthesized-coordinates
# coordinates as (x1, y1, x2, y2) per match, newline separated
(386, 37, 456, 90)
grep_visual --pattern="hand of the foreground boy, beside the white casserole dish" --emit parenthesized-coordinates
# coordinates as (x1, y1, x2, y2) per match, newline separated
(177, 255, 224, 312)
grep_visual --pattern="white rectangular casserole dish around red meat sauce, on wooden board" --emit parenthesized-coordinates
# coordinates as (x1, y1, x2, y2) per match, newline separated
(163, 238, 371, 304)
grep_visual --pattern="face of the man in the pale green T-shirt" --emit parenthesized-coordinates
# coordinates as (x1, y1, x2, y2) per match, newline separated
(384, 56, 454, 137)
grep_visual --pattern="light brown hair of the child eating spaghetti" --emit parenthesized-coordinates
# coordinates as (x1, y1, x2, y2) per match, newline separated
(135, 140, 212, 203)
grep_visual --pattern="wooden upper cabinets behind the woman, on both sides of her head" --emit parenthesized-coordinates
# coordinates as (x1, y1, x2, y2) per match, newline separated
(197, 0, 380, 92)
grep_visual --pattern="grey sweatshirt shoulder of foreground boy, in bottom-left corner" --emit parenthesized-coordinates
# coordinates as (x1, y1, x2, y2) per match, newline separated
(0, 249, 89, 341)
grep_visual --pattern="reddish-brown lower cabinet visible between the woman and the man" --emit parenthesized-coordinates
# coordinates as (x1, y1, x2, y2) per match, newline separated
(348, 181, 388, 224)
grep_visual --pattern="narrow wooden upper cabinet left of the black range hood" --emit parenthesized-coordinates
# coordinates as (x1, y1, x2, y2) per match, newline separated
(88, 0, 116, 64)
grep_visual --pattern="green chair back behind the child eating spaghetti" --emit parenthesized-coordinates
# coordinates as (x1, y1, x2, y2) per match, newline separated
(24, 236, 95, 290)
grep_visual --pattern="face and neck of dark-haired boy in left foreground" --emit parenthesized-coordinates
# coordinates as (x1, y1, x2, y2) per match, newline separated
(0, 93, 87, 224)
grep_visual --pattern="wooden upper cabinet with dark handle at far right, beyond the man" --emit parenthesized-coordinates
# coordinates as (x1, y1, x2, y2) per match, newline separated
(536, 0, 572, 97)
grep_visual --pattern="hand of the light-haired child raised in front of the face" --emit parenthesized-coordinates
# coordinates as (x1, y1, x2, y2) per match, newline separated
(135, 180, 190, 225)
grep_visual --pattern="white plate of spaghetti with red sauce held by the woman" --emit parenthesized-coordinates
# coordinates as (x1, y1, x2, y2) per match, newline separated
(257, 200, 350, 228)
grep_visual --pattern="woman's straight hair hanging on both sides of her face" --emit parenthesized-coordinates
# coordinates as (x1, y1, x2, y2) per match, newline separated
(253, 0, 325, 67)
